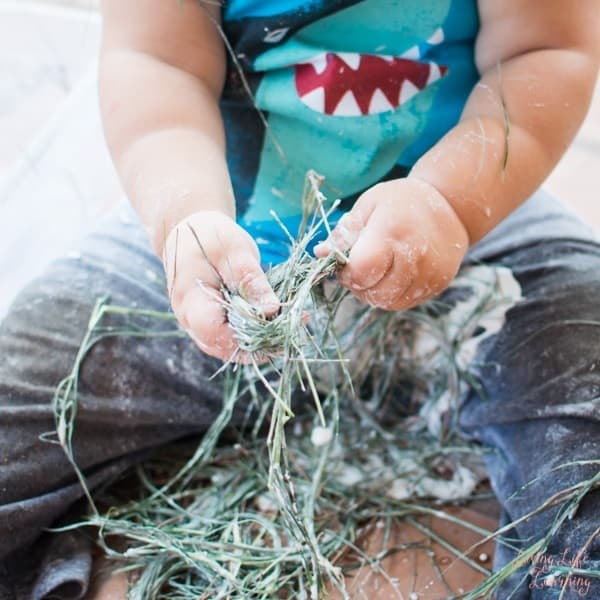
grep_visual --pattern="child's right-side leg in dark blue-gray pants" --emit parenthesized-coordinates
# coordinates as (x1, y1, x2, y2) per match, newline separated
(461, 195, 600, 600)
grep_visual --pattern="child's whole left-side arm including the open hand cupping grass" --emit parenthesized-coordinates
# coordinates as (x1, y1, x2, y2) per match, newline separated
(100, 0, 278, 359)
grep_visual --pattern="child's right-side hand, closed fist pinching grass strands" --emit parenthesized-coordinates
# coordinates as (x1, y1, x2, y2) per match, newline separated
(315, 178, 469, 310)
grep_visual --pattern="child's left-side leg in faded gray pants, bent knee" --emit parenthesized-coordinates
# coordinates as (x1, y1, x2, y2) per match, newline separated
(0, 207, 237, 599)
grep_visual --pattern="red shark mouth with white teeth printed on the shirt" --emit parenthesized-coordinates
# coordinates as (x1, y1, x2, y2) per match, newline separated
(295, 52, 448, 117)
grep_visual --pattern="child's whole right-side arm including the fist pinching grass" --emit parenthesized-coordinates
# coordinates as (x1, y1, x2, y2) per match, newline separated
(318, 0, 600, 309)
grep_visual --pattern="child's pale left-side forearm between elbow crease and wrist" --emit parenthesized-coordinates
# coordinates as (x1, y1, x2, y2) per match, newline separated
(101, 50, 235, 253)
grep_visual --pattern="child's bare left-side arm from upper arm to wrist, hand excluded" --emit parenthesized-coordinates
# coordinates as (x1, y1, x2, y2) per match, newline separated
(100, 0, 234, 254)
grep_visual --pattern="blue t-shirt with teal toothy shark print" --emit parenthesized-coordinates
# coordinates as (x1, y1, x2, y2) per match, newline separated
(221, 0, 479, 263)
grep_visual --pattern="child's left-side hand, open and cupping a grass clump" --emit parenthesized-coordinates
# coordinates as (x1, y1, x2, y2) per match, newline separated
(164, 211, 279, 361)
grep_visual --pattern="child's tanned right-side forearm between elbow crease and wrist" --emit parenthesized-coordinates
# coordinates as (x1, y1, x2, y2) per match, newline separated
(411, 4, 598, 243)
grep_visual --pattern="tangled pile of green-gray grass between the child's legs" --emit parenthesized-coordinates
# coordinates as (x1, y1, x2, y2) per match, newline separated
(49, 175, 598, 599)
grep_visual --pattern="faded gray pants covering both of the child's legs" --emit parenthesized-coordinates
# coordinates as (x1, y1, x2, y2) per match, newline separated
(0, 193, 600, 600)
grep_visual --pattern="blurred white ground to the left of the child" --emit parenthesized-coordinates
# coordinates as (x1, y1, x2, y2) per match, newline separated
(0, 2, 121, 316)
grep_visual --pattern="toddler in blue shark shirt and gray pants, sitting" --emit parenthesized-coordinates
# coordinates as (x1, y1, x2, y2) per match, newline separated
(0, 0, 600, 599)
